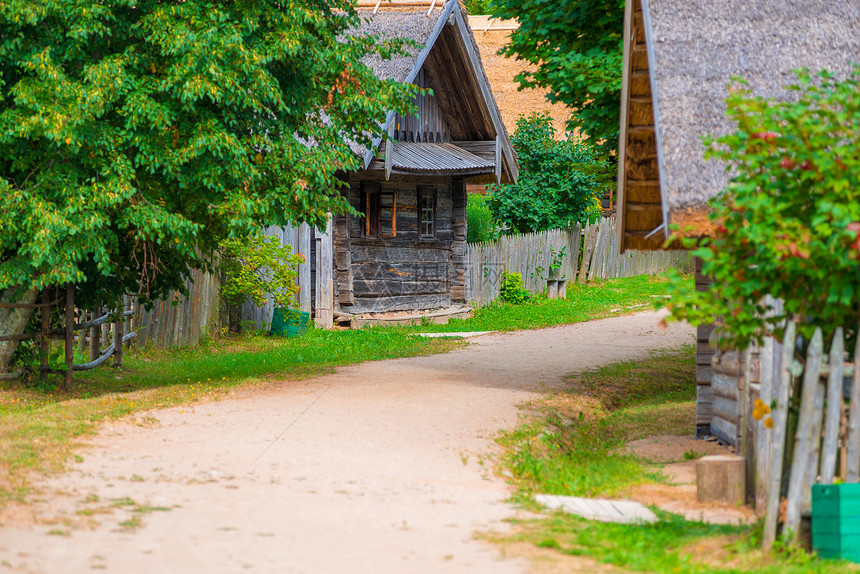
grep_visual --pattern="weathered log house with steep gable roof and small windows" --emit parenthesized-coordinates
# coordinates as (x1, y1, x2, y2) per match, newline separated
(330, 0, 518, 320)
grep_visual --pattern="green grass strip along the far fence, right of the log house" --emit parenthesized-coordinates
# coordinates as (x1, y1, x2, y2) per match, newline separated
(394, 275, 667, 333)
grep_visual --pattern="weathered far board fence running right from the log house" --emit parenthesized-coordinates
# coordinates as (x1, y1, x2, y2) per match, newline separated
(466, 217, 692, 306)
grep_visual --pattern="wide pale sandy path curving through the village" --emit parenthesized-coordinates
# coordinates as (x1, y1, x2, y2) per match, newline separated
(0, 313, 693, 574)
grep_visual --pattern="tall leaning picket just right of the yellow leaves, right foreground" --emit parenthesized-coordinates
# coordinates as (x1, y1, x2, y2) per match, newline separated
(762, 319, 797, 551)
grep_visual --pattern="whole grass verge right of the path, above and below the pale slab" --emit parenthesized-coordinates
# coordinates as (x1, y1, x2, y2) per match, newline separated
(491, 345, 860, 574)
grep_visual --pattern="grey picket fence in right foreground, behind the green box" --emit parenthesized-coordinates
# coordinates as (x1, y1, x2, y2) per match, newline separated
(724, 321, 860, 548)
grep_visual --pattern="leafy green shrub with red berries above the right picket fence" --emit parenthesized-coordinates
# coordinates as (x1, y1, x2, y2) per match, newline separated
(667, 71, 860, 354)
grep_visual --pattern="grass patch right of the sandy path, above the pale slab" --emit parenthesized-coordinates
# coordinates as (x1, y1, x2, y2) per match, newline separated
(500, 345, 696, 500)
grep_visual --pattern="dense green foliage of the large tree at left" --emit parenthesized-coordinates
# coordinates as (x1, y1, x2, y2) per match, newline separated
(0, 0, 413, 306)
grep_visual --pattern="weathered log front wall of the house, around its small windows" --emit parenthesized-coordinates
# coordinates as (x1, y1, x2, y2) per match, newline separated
(334, 172, 456, 314)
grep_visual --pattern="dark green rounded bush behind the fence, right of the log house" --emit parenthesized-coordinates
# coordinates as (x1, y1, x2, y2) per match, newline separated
(487, 113, 605, 233)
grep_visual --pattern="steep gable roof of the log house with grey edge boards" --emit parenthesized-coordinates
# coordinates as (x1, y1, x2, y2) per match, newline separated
(357, 0, 519, 181)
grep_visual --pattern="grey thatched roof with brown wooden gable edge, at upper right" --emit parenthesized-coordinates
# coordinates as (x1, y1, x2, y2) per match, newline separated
(618, 0, 860, 249)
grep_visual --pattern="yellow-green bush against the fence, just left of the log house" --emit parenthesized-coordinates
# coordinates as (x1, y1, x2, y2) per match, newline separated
(220, 235, 305, 309)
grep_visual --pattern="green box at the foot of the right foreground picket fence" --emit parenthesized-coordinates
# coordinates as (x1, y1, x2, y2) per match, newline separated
(812, 484, 860, 563)
